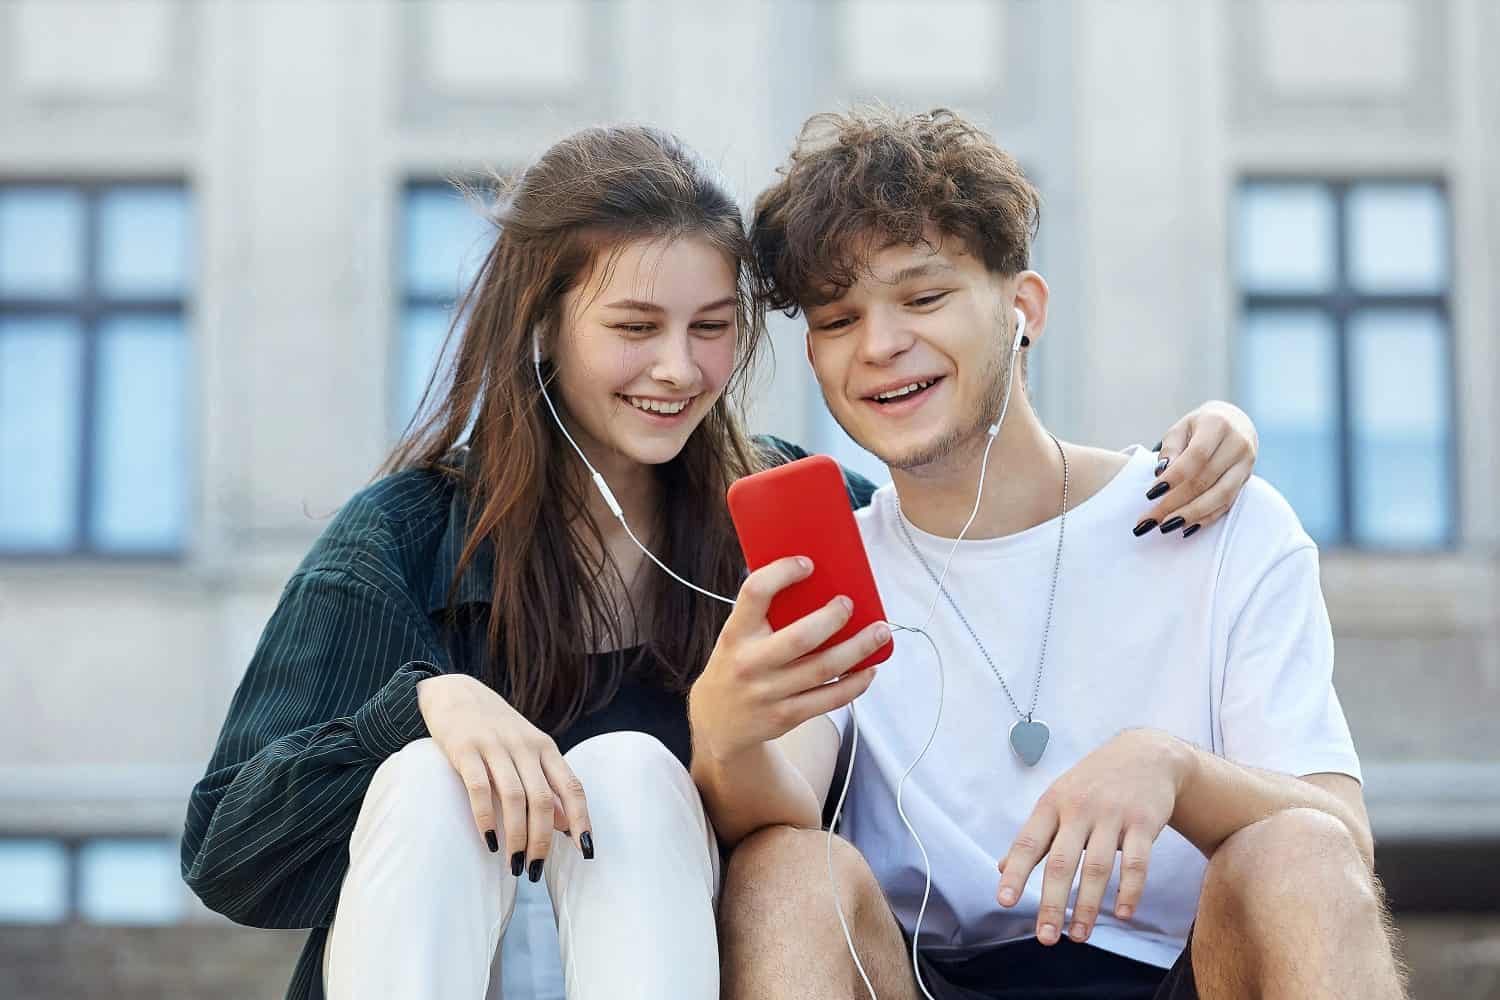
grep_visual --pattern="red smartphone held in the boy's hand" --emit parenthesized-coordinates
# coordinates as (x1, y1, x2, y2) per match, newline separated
(729, 454, 894, 673)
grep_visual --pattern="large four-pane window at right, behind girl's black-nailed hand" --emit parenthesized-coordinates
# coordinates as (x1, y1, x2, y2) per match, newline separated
(1235, 180, 1457, 550)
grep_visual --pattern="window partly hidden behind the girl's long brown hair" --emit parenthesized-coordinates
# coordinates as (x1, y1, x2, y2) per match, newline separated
(393, 181, 494, 432)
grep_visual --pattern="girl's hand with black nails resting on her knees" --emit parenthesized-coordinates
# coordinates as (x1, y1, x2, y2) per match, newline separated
(417, 673, 594, 882)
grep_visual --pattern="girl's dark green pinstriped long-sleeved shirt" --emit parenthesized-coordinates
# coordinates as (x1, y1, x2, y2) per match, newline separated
(182, 438, 875, 1000)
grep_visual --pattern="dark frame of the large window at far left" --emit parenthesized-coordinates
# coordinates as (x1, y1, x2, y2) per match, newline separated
(0, 174, 197, 564)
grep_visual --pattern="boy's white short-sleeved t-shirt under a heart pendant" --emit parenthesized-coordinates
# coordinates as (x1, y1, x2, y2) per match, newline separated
(830, 447, 1359, 967)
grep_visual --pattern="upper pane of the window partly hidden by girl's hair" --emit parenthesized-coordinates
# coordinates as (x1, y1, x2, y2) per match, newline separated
(402, 187, 495, 301)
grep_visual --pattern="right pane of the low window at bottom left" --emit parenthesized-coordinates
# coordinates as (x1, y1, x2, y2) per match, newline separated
(78, 838, 183, 924)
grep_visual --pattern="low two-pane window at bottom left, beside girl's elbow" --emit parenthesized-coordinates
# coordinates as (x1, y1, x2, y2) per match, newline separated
(0, 837, 186, 925)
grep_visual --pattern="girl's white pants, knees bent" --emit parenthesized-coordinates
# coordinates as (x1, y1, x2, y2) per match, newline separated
(324, 733, 720, 1000)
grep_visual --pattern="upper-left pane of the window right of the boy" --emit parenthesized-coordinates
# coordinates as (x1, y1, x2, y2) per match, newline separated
(1236, 181, 1337, 294)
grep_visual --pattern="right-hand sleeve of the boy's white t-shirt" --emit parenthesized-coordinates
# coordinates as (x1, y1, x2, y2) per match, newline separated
(1215, 543, 1361, 781)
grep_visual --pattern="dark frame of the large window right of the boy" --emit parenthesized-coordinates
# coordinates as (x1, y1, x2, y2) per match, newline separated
(1229, 172, 1463, 555)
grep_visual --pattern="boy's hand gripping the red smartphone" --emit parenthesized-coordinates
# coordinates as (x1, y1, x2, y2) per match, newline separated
(689, 556, 891, 760)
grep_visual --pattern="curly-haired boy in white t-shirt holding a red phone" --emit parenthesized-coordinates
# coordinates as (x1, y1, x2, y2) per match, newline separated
(690, 111, 1403, 1000)
